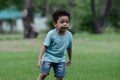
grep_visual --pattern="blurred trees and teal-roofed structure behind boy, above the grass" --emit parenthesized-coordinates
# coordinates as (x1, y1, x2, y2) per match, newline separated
(0, 0, 120, 38)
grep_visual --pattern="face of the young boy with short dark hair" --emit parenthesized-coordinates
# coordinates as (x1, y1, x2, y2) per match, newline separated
(54, 16, 69, 32)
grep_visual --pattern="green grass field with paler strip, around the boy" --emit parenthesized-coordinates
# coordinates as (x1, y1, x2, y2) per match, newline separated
(0, 34, 120, 80)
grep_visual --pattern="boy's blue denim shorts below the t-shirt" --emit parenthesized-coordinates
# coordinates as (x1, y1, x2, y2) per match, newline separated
(41, 61, 66, 78)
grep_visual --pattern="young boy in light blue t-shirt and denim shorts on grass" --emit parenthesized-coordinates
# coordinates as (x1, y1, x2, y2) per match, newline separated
(37, 10, 72, 80)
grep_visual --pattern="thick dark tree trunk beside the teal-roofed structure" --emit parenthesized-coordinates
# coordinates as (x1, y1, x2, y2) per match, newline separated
(23, 0, 38, 38)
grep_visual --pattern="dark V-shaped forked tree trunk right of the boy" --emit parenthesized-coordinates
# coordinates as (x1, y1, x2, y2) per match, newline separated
(91, 0, 111, 34)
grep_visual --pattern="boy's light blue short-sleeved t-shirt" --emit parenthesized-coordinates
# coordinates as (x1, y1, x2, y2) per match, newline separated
(42, 29, 72, 63)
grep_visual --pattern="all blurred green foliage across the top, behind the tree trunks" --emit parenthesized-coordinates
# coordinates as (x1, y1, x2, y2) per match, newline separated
(0, 0, 120, 33)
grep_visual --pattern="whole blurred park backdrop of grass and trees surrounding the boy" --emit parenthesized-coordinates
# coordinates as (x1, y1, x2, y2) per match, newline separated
(0, 0, 120, 80)
